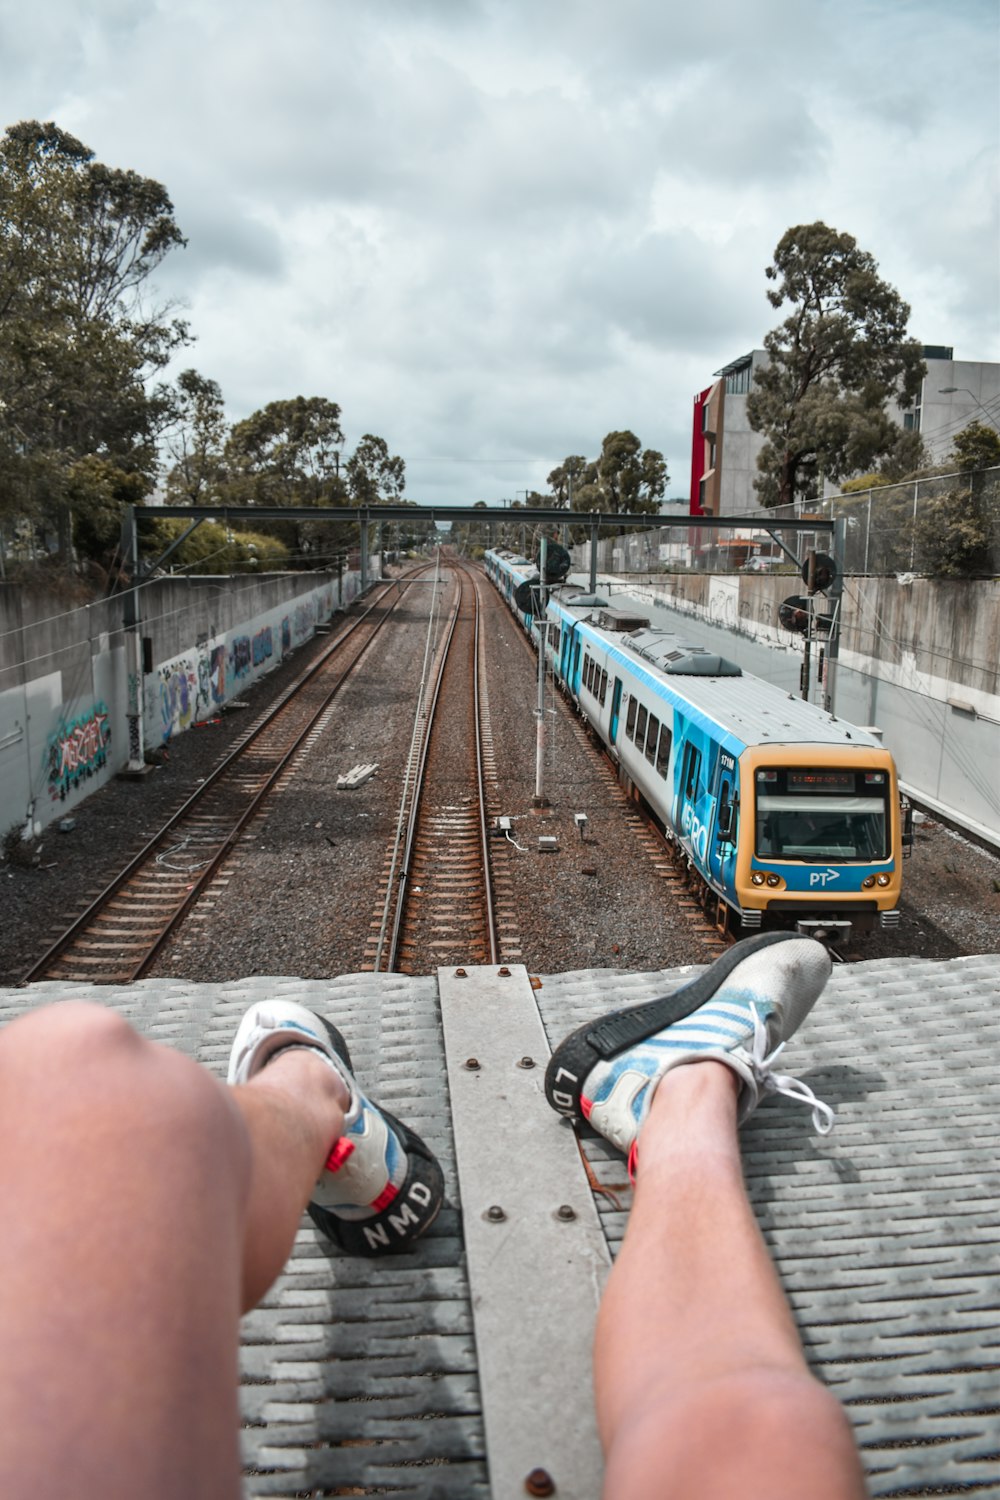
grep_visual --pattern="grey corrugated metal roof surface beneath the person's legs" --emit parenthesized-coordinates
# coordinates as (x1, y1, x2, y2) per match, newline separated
(0, 954, 1000, 1500)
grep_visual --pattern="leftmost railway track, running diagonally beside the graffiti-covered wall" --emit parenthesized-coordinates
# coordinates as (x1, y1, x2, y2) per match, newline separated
(21, 582, 419, 984)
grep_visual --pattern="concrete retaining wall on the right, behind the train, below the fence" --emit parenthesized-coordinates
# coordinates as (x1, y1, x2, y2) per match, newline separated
(590, 573, 1000, 845)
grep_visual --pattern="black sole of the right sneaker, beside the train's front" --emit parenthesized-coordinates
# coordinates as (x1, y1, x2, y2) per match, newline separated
(546, 933, 801, 1116)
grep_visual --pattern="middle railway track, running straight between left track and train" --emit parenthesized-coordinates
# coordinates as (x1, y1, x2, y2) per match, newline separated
(366, 566, 498, 974)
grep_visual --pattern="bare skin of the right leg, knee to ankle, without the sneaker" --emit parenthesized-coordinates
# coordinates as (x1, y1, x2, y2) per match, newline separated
(595, 1062, 865, 1500)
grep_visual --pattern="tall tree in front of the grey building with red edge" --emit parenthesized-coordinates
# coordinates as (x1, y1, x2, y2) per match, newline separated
(747, 224, 927, 506)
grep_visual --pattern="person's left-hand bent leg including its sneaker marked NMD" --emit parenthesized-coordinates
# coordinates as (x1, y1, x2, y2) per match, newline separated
(0, 1004, 441, 1500)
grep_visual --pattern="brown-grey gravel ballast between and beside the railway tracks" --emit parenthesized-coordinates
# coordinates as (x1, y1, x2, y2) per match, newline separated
(0, 573, 1000, 984)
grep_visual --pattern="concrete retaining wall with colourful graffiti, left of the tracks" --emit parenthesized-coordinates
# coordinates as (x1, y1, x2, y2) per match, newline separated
(0, 558, 378, 836)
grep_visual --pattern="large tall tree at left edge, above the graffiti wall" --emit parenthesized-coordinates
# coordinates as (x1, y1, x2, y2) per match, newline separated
(0, 120, 187, 557)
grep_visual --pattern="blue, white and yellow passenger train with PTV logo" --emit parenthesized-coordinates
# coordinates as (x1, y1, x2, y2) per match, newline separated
(484, 549, 913, 941)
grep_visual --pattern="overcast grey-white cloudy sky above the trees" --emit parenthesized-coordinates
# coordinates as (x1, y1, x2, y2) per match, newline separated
(0, 0, 1000, 504)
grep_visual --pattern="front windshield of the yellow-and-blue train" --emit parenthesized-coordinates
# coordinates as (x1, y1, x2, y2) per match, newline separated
(756, 770, 891, 863)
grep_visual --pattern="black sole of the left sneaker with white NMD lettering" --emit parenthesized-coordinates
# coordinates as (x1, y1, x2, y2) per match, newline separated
(307, 1016, 444, 1259)
